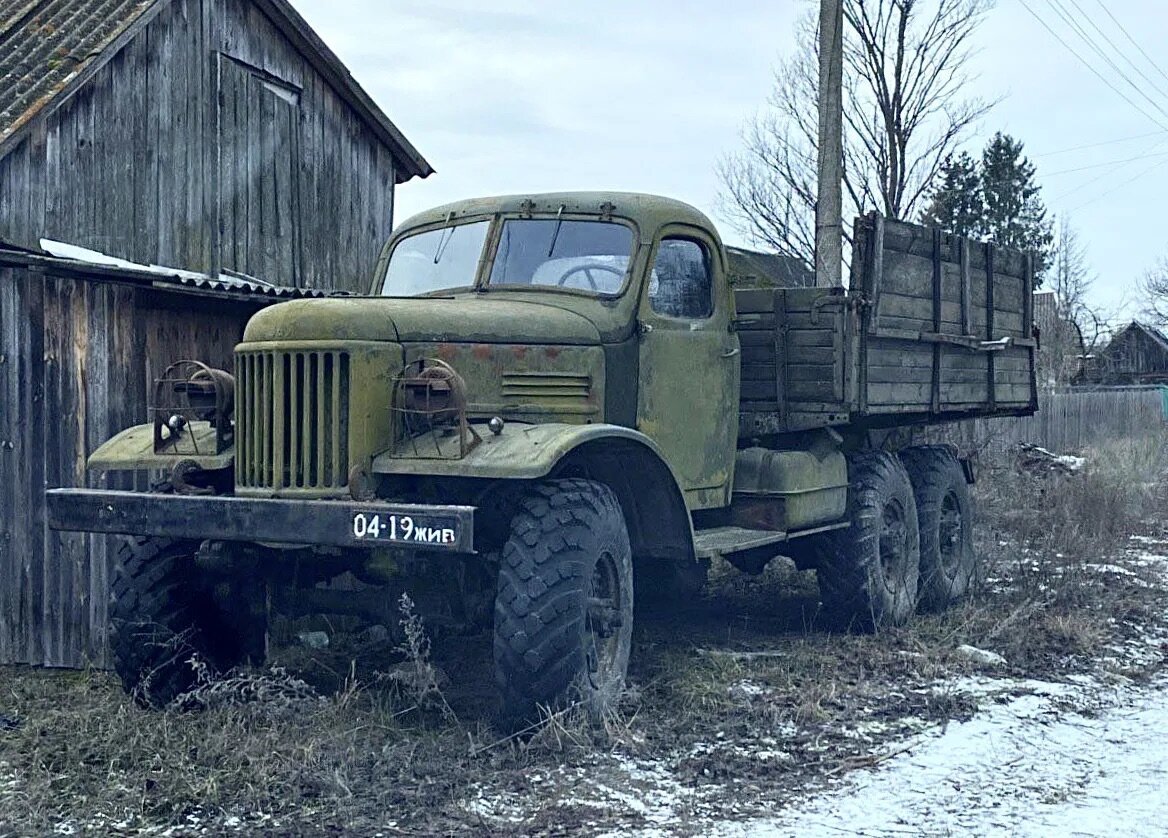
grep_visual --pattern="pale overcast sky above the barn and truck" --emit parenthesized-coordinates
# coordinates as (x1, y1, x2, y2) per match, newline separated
(292, 0, 1168, 314)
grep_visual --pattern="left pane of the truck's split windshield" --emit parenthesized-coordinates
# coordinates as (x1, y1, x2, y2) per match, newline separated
(381, 221, 491, 297)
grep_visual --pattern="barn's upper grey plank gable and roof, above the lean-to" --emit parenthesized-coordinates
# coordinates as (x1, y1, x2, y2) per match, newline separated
(0, 0, 431, 290)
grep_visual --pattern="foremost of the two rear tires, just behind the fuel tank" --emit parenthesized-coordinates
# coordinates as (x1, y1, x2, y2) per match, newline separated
(813, 451, 920, 631)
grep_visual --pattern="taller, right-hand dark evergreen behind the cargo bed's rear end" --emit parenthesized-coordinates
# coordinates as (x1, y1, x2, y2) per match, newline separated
(981, 132, 1055, 281)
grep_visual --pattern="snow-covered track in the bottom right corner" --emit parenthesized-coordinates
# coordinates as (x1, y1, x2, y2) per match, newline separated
(714, 681, 1168, 838)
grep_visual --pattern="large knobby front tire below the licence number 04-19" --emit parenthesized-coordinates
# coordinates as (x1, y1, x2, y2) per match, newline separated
(494, 479, 633, 722)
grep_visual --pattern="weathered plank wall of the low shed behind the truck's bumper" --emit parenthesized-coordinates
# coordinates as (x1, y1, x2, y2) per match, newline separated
(0, 268, 258, 666)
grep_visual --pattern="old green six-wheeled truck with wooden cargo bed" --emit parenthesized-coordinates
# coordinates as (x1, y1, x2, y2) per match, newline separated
(47, 193, 1036, 715)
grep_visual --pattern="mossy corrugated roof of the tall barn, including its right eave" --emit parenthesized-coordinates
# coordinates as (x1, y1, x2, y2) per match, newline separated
(0, 0, 433, 182)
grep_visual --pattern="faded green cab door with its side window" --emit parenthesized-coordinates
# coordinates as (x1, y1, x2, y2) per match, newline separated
(637, 226, 739, 508)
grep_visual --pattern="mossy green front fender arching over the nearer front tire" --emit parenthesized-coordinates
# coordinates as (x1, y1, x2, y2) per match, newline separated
(371, 422, 677, 483)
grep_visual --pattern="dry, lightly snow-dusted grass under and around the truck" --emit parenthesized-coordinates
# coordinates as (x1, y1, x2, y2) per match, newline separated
(0, 427, 1168, 836)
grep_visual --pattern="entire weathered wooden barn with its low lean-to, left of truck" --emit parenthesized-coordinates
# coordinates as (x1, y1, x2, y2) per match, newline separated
(0, 0, 431, 666)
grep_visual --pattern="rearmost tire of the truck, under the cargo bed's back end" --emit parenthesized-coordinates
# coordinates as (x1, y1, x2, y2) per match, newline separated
(901, 445, 978, 611)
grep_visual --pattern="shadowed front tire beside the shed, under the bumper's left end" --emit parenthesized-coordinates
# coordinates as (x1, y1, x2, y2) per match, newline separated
(110, 538, 259, 708)
